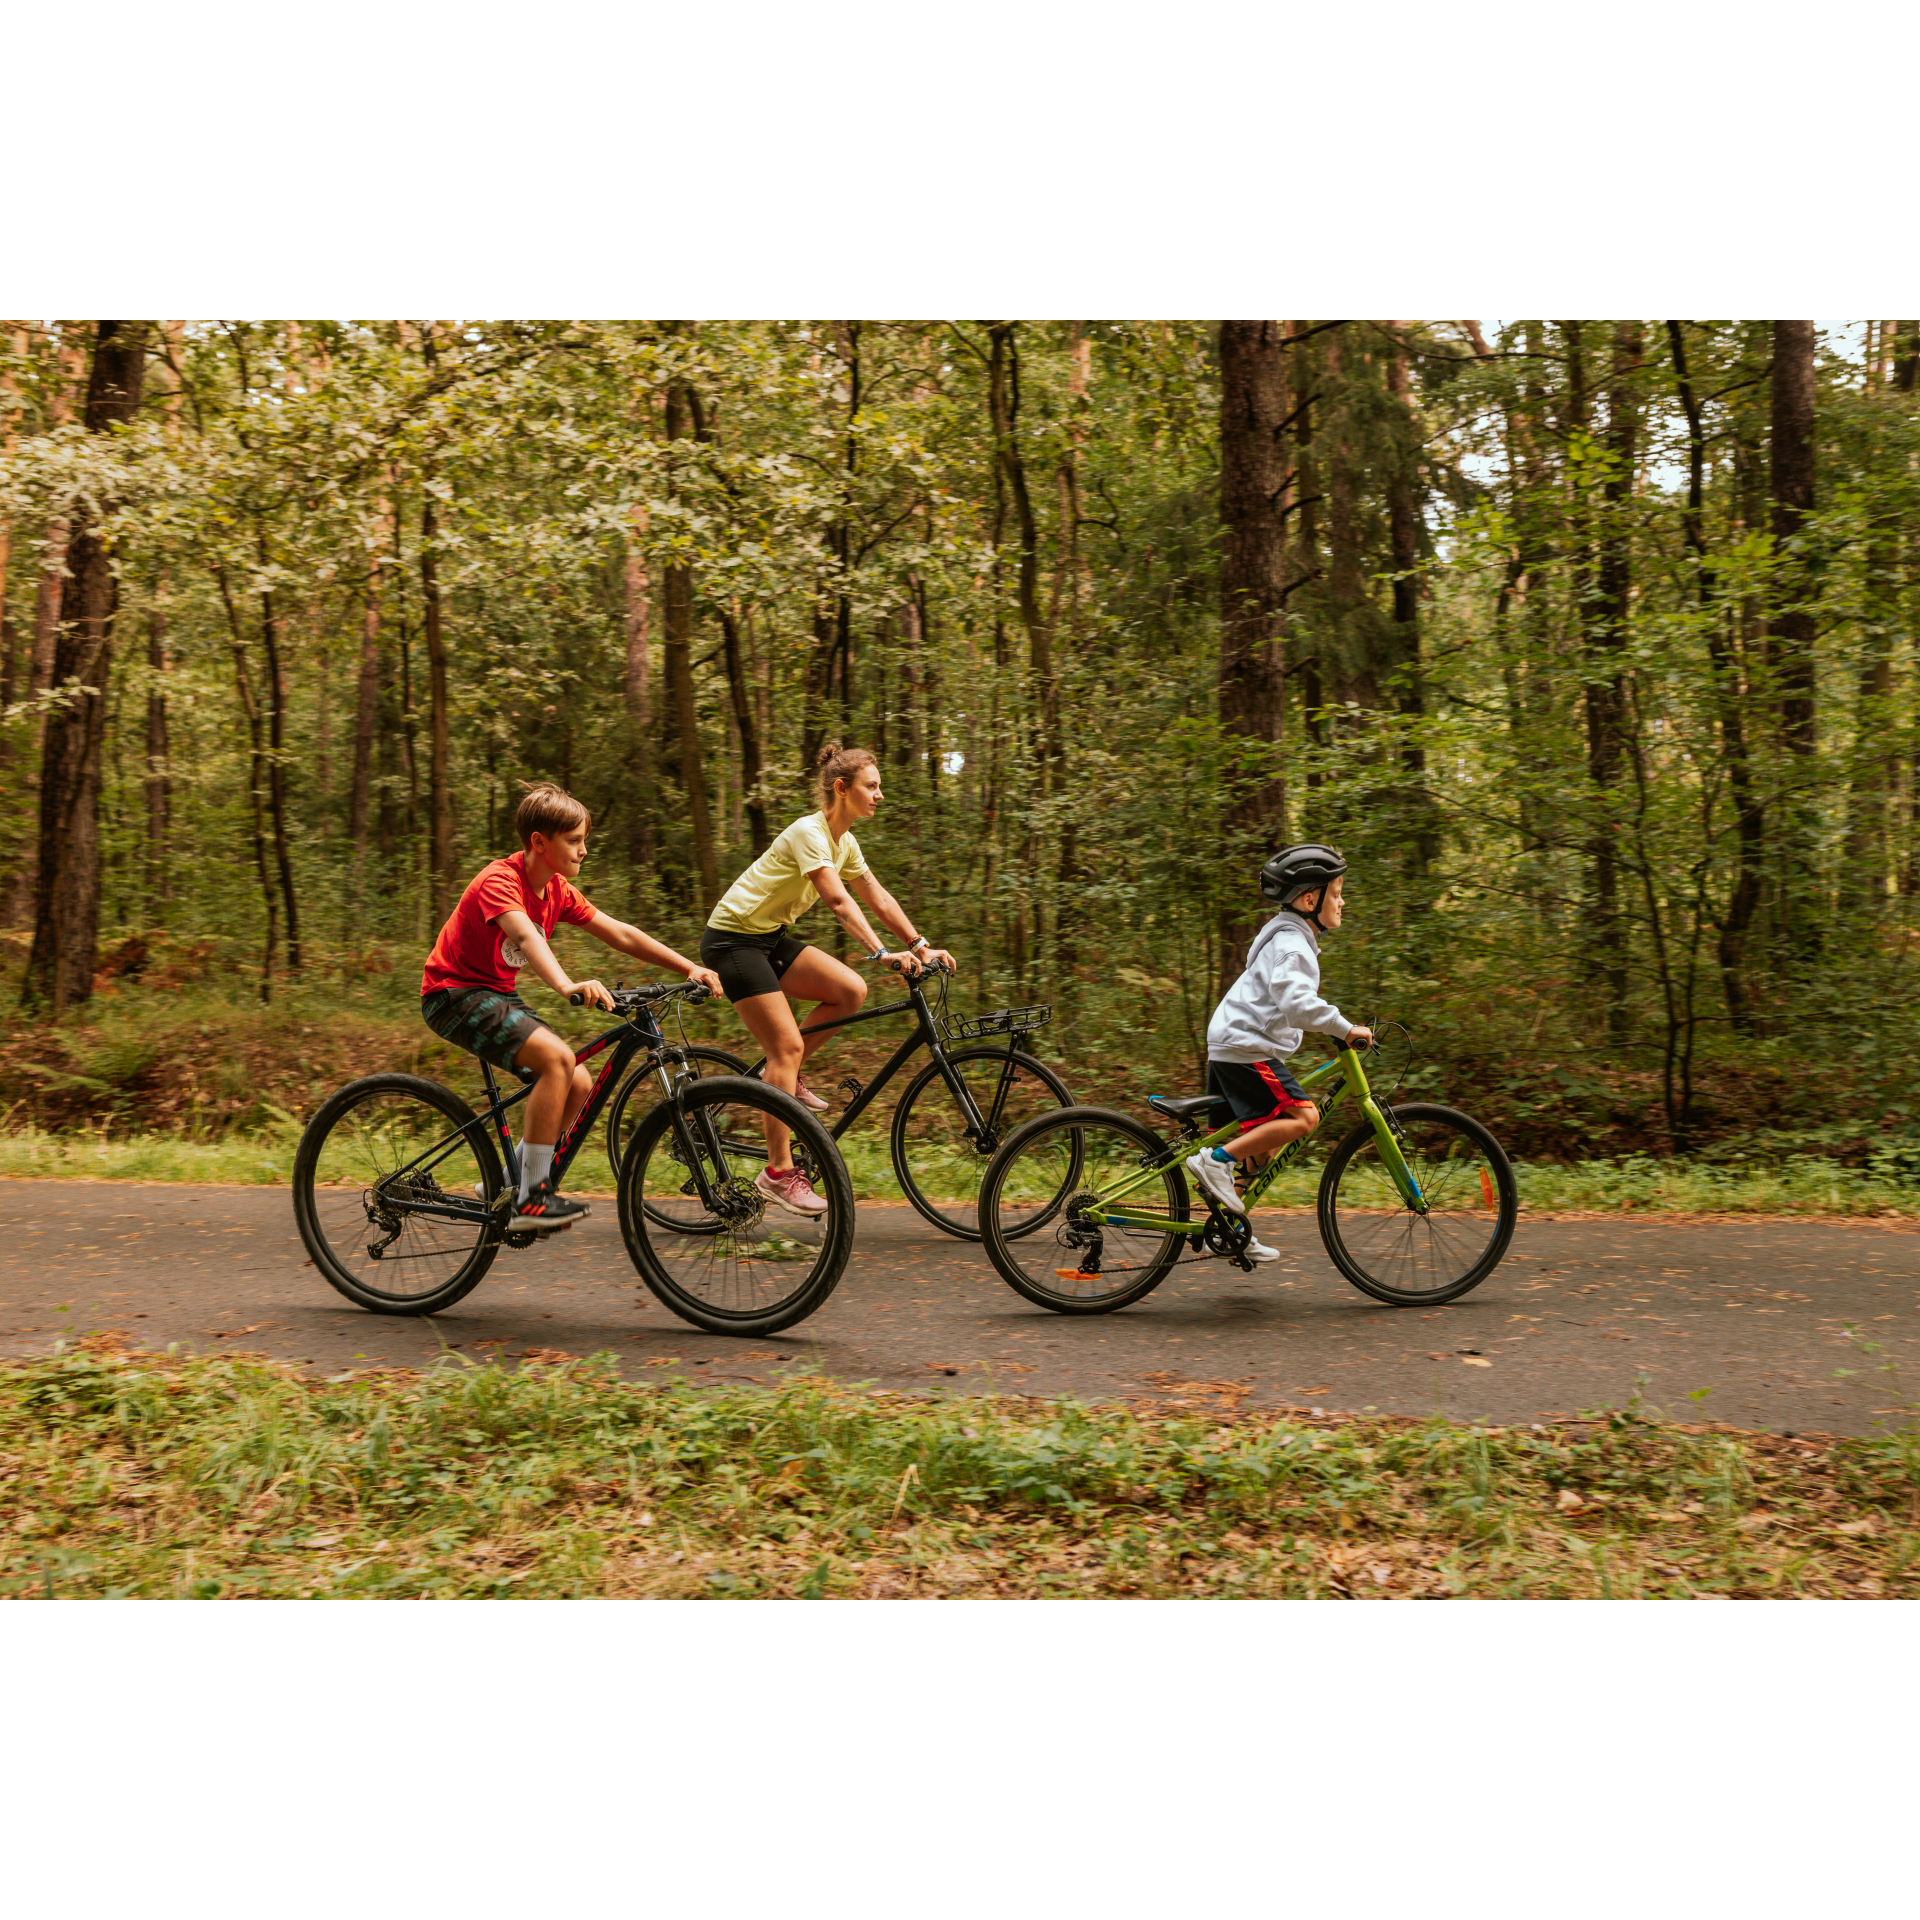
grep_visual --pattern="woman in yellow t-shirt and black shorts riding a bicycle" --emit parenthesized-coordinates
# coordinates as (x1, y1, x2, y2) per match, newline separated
(701, 741, 954, 1213)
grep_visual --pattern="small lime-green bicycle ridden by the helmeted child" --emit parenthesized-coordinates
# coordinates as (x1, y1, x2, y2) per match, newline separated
(979, 1025, 1519, 1313)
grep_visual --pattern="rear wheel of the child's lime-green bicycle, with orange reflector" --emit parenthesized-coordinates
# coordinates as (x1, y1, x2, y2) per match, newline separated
(979, 1106, 1190, 1313)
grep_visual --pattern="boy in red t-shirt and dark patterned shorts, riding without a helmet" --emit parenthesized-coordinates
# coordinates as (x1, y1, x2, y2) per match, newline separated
(420, 787, 720, 1233)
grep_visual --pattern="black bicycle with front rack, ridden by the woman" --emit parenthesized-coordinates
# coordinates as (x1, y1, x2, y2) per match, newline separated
(607, 966, 1073, 1240)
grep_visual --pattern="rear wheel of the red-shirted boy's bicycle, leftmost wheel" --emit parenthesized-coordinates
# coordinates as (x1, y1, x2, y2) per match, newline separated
(294, 1073, 501, 1313)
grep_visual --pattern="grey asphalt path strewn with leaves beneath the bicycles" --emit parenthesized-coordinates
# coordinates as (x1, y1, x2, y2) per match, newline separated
(0, 1181, 1920, 1432)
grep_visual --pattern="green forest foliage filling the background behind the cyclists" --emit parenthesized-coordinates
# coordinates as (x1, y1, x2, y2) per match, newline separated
(0, 321, 1920, 1179)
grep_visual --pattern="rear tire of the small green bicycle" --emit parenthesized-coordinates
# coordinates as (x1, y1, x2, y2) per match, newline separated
(979, 1106, 1192, 1313)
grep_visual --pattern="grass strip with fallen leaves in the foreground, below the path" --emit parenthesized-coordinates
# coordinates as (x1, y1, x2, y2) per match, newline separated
(11, 1336, 1920, 1597)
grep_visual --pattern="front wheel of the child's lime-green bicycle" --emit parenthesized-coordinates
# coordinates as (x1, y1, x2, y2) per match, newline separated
(1319, 1106, 1521, 1308)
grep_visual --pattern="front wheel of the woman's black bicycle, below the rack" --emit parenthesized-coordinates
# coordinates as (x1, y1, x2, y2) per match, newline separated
(893, 1046, 1073, 1240)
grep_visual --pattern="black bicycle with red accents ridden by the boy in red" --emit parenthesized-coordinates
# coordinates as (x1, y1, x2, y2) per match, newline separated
(294, 981, 852, 1334)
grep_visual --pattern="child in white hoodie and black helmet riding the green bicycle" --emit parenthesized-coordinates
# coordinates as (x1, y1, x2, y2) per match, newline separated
(1187, 843, 1373, 1260)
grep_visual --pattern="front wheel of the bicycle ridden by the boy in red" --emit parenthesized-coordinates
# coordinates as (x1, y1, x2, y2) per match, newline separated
(620, 1073, 854, 1338)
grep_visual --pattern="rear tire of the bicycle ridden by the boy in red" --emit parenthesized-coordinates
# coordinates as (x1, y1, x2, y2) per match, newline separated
(294, 1073, 501, 1317)
